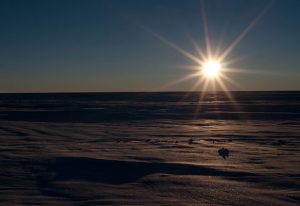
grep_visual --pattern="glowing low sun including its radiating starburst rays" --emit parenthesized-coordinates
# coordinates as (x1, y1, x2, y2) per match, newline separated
(140, 2, 272, 117)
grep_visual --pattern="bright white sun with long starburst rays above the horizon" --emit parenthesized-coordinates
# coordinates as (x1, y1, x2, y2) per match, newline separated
(140, 1, 271, 117)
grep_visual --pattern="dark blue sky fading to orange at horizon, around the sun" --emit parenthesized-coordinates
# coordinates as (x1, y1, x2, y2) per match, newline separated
(0, 0, 300, 92)
